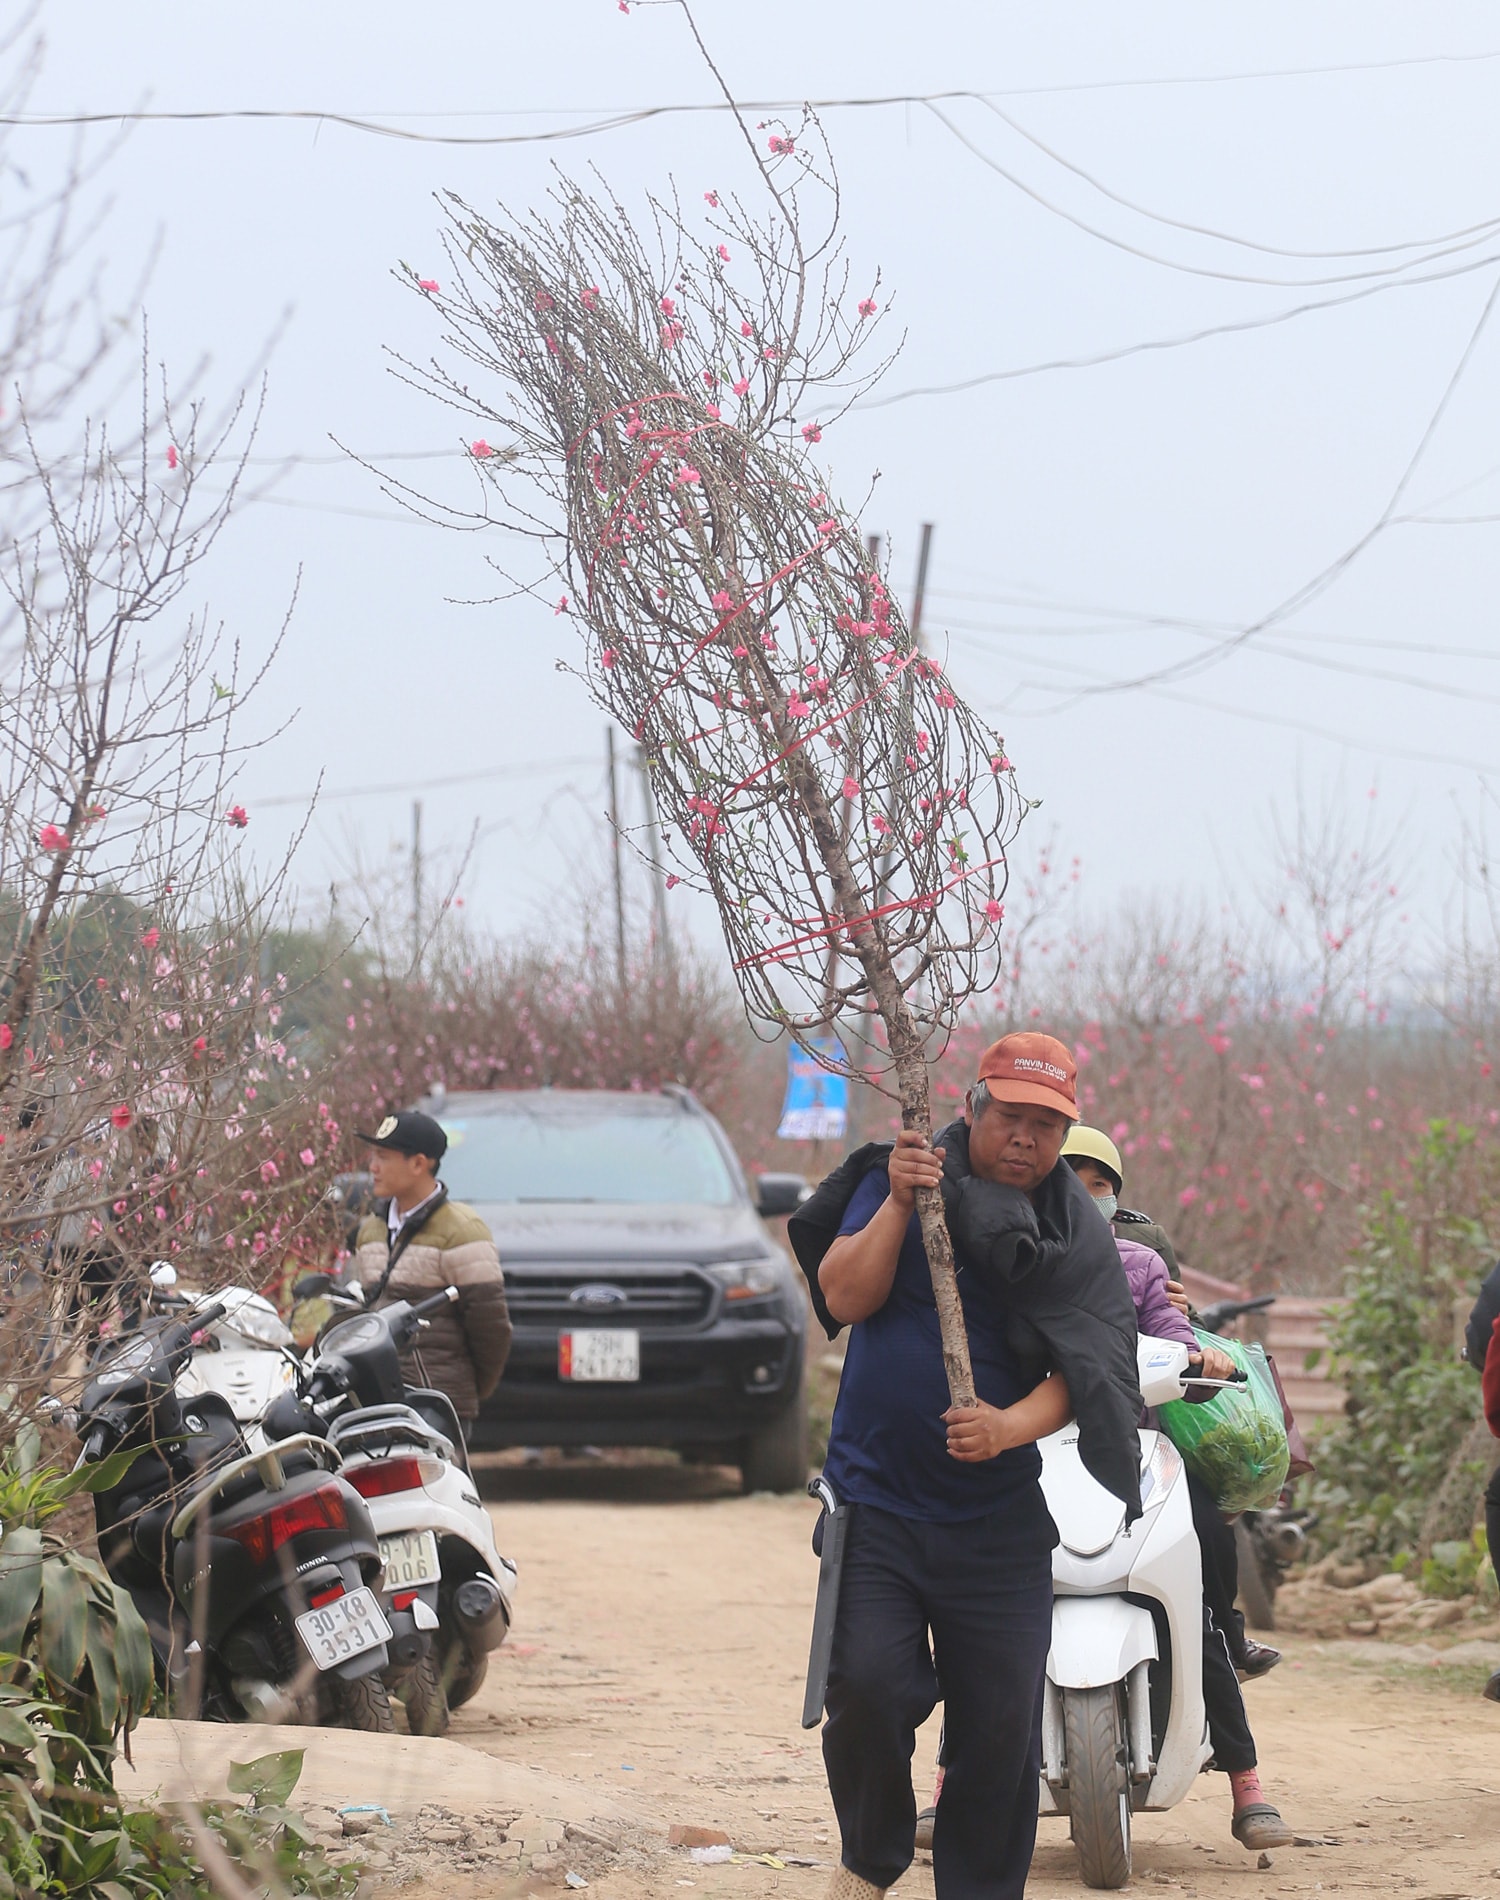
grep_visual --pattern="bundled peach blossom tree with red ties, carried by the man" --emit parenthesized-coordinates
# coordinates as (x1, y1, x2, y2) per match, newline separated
(407, 118, 1025, 1402)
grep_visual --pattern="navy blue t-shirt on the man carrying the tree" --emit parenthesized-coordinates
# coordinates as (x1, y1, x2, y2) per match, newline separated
(823, 1169, 1042, 1524)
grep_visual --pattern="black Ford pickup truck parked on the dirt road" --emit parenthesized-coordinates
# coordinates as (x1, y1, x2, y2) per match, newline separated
(432, 1089, 808, 1492)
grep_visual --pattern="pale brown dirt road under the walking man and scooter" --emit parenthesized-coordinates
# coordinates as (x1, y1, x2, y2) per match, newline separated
(405, 1465, 1500, 1900)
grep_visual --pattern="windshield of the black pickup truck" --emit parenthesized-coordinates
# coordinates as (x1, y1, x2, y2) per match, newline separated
(433, 1110, 736, 1207)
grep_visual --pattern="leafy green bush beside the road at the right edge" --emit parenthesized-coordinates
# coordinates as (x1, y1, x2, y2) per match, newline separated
(1308, 1121, 1494, 1560)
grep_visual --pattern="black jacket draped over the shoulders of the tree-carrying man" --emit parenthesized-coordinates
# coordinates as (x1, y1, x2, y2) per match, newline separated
(787, 1121, 1141, 1520)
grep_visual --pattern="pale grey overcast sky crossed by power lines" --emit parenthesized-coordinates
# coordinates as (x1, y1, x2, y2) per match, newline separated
(15, 0, 1500, 965)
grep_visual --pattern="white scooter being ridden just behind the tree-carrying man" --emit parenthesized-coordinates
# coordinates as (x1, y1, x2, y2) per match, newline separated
(1040, 1340, 1238, 1887)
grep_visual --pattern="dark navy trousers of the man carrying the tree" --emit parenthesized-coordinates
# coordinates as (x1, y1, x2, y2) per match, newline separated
(823, 1484, 1057, 1900)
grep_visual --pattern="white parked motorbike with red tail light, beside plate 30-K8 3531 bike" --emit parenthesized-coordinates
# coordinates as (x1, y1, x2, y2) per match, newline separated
(256, 1288, 515, 1735)
